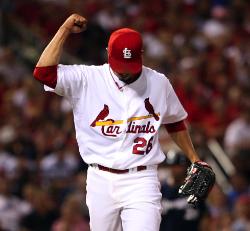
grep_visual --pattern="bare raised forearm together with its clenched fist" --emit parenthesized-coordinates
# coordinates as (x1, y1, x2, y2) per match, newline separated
(36, 14, 87, 67)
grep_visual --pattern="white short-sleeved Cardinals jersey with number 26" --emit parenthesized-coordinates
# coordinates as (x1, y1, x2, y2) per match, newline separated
(45, 64, 187, 169)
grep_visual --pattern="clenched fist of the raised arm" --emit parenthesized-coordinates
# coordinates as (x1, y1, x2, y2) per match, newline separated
(61, 14, 87, 33)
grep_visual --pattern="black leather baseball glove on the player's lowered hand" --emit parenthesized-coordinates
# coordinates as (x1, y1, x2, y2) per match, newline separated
(179, 161, 215, 205)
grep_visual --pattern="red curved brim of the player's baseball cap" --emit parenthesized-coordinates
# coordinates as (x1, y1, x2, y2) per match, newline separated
(108, 57, 142, 74)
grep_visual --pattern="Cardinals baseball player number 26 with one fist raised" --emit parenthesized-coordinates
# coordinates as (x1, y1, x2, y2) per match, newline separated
(34, 14, 216, 231)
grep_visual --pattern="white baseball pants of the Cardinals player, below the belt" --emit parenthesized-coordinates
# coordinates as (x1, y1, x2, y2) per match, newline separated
(86, 166, 161, 231)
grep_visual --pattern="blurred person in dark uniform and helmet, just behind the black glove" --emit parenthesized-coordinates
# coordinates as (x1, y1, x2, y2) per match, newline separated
(160, 150, 206, 231)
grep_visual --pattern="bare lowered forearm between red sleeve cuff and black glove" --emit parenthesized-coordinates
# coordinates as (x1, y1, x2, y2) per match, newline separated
(170, 130, 199, 162)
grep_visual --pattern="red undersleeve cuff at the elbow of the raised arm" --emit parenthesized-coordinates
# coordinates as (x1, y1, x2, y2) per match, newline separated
(33, 65, 58, 89)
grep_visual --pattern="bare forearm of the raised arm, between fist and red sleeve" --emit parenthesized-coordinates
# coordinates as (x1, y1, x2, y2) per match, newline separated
(36, 27, 70, 67)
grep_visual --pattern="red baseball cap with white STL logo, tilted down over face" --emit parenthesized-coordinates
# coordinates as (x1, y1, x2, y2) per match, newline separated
(108, 28, 143, 74)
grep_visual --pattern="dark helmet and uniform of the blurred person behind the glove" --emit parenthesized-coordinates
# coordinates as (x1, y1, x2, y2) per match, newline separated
(160, 153, 206, 231)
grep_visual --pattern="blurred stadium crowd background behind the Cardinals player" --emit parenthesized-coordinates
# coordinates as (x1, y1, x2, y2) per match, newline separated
(0, 0, 250, 231)
